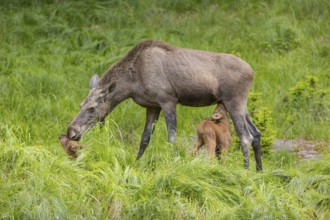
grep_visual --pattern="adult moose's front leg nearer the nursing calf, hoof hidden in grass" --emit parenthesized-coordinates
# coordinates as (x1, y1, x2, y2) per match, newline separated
(162, 103, 176, 142)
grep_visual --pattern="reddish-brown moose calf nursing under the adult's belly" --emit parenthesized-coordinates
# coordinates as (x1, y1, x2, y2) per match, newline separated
(193, 104, 232, 160)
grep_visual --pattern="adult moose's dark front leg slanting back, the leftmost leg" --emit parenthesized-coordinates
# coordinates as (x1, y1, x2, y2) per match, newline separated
(136, 108, 161, 160)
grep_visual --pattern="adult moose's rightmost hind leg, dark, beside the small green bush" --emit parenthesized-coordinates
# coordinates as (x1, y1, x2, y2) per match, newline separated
(245, 112, 262, 171)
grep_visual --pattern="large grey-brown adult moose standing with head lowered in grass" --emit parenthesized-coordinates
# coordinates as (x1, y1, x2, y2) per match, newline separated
(67, 40, 262, 171)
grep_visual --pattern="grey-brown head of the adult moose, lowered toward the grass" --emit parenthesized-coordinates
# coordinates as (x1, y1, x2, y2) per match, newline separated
(67, 74, 116, 141)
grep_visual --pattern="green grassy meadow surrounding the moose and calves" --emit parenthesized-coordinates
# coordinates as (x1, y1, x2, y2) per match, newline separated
(0, 0, 330, 219)
